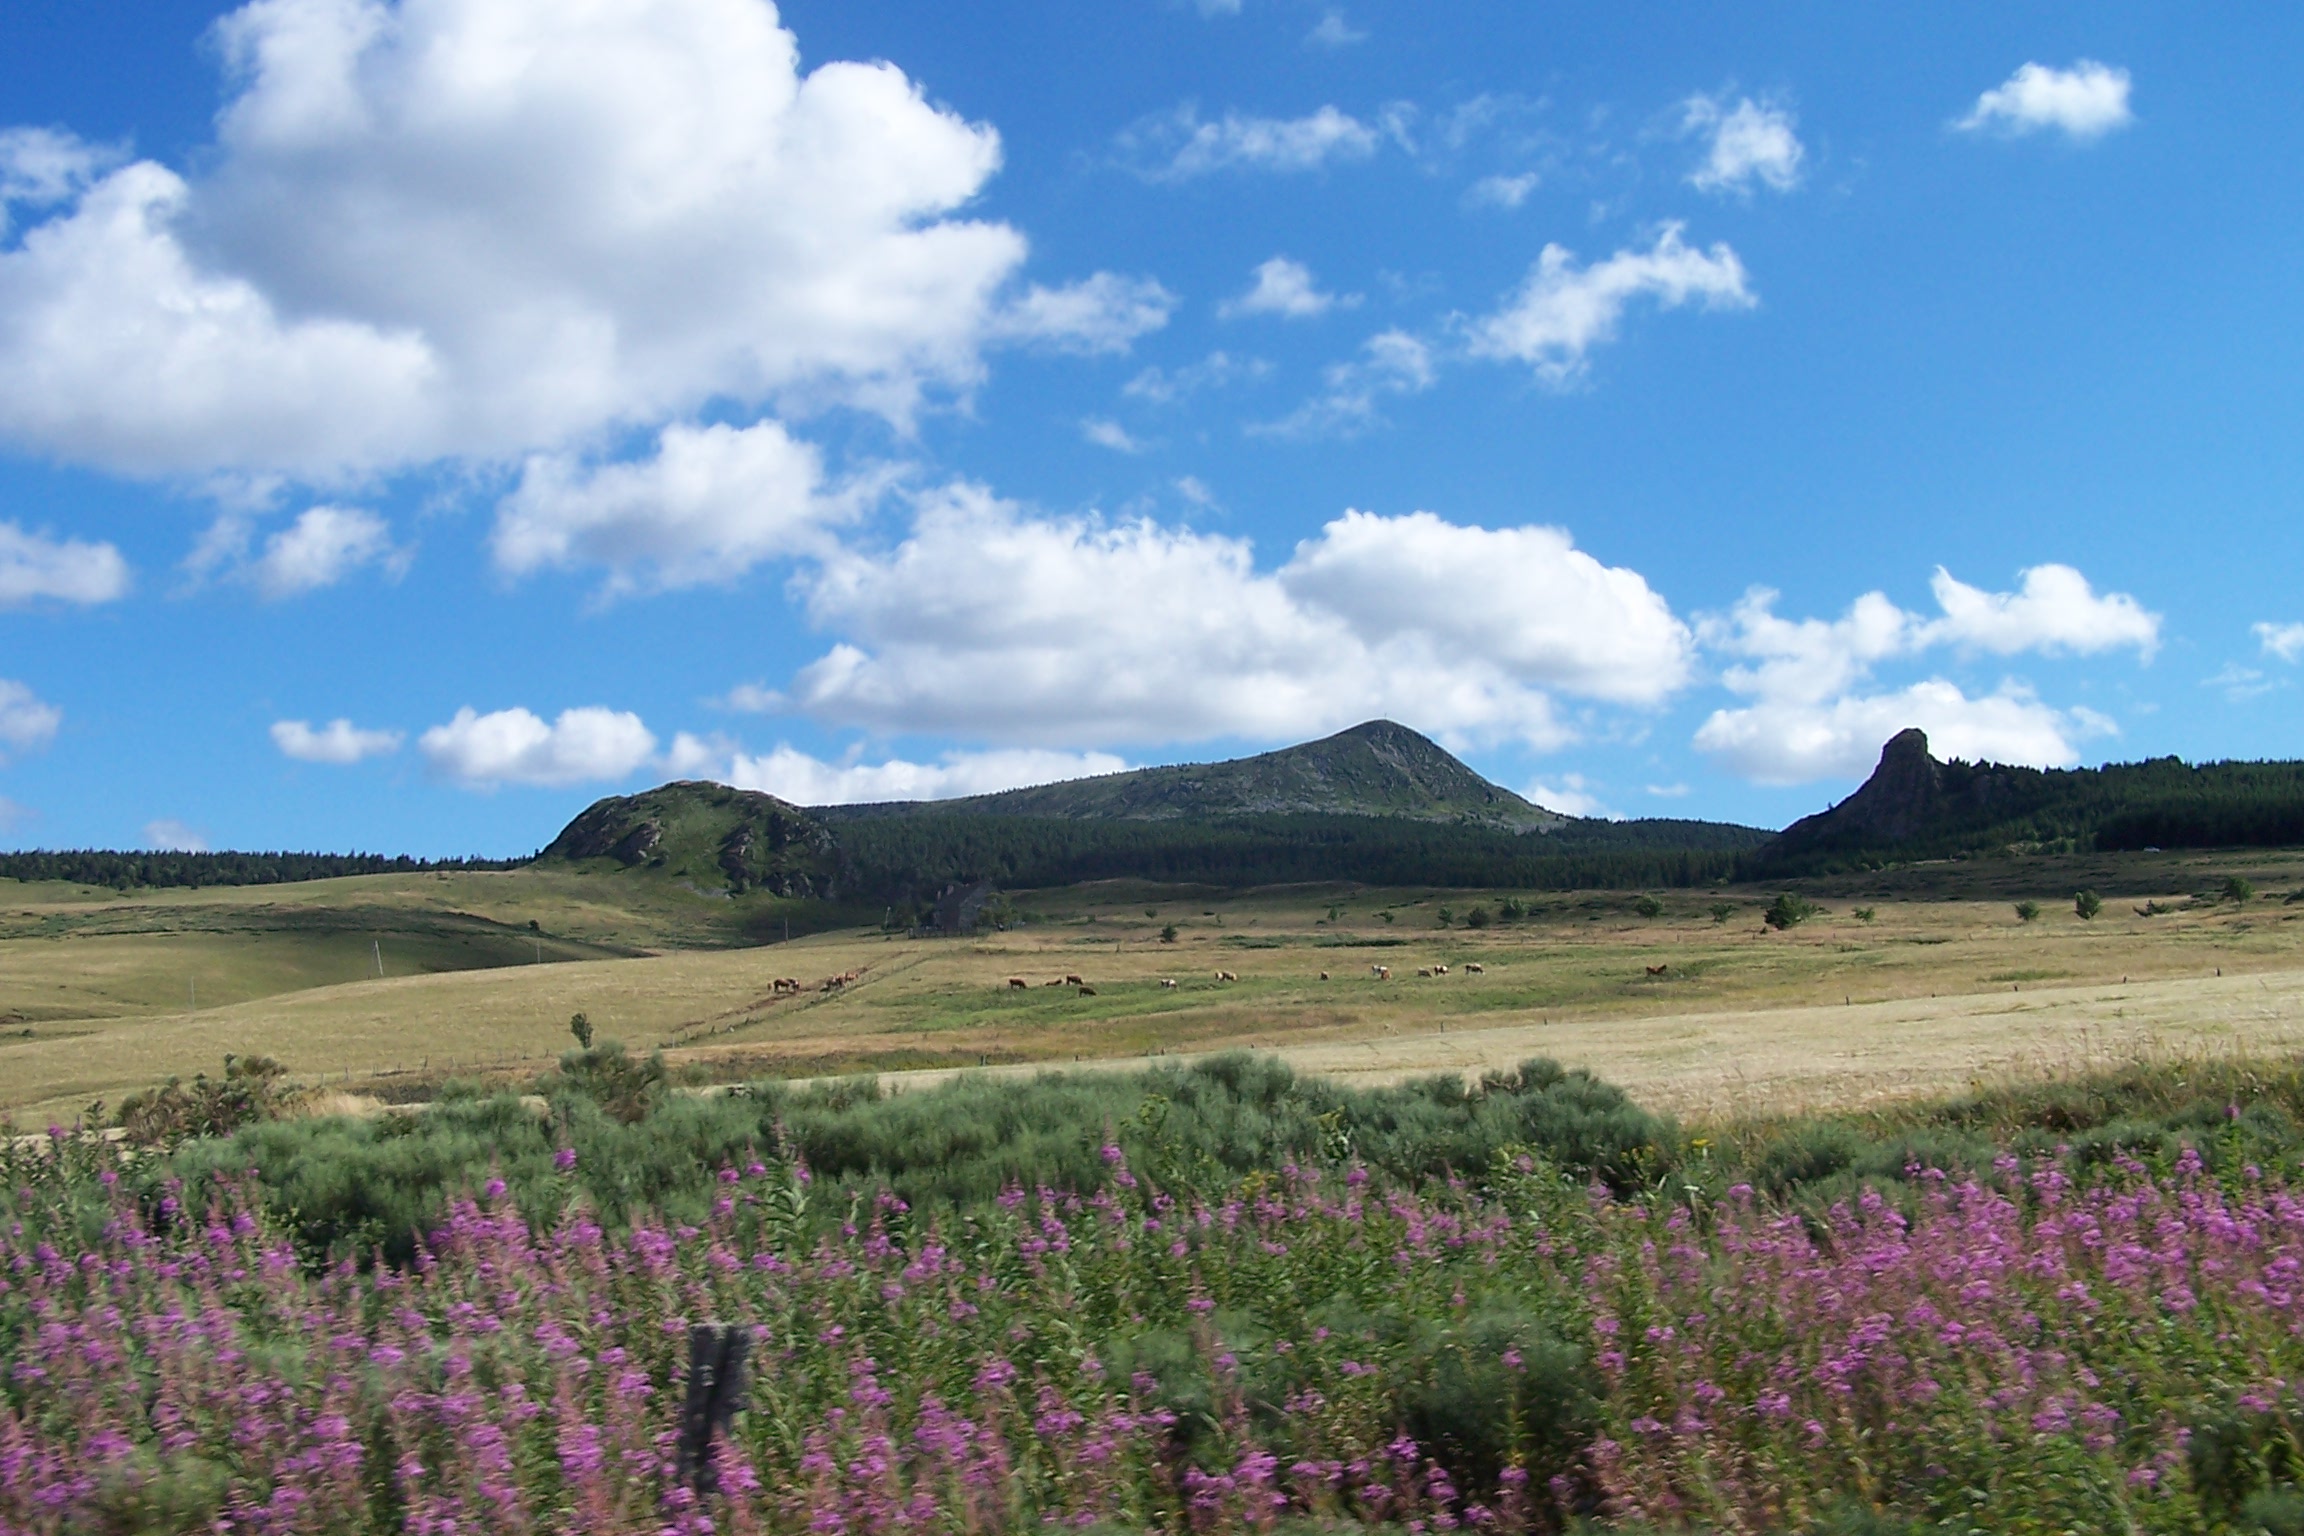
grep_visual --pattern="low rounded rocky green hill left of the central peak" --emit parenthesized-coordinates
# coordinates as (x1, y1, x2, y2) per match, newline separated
(537, 781, 839, 896)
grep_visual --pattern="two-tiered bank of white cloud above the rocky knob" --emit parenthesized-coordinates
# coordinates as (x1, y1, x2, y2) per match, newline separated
(1696, 564, 2159, 783)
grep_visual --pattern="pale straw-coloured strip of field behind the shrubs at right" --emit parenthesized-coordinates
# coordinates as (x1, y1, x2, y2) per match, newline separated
(838, 969, 2304, 1117)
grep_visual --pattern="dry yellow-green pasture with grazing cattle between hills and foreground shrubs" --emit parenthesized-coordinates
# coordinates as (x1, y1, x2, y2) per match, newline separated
(0, 854, 2304, 1124)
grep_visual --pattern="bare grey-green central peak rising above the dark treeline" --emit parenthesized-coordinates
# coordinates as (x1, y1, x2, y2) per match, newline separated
(813, 721, 1569, 831)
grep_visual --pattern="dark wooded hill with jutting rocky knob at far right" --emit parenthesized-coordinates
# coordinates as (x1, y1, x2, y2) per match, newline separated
(1744, 730, 2304, 880)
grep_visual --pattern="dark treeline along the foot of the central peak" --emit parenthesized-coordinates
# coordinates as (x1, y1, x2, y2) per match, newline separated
(834, 811, 1772, 900)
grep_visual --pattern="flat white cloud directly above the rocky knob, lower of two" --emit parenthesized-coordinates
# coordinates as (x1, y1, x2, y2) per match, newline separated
(1696, 677, 2110, 783)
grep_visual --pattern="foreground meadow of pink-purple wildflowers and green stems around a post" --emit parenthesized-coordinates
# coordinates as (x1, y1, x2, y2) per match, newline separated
(0, 1073, 2304, 1536)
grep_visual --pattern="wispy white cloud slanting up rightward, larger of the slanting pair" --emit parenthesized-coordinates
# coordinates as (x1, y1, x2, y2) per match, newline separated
(1470, 223, 1758, 385)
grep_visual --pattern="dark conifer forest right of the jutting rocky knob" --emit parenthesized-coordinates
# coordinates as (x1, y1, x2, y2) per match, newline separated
(1744, 758, 2304, 877)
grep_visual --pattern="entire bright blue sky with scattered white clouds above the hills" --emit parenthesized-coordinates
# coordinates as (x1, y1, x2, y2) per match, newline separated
(0, 0, 2304, 854)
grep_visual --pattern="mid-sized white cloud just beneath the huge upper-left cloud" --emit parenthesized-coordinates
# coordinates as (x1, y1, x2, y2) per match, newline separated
(491, 421, 857, 590)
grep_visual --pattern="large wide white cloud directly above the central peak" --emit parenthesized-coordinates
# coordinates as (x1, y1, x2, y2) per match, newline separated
(779, 486, 1691, 748)
